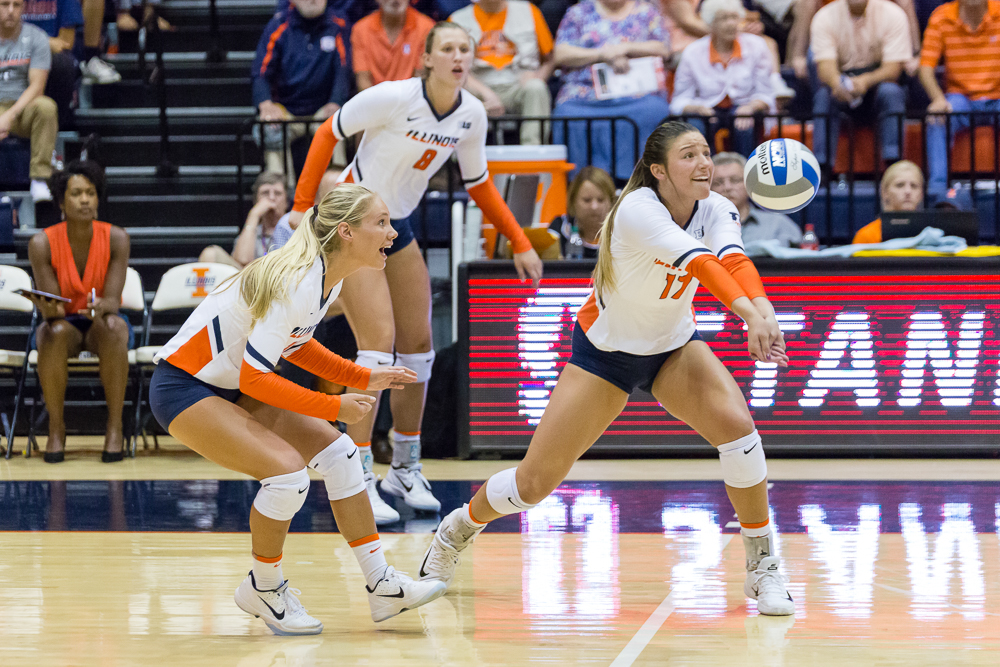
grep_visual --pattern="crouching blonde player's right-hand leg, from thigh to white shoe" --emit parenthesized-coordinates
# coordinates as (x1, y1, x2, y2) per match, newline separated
(239, 396, 445, 621)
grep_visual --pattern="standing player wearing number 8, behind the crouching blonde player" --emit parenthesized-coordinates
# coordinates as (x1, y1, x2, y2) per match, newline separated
(289, 23, 542, 523)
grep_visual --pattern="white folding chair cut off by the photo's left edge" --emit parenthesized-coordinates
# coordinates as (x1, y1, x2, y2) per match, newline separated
(0, 265, 36, 459)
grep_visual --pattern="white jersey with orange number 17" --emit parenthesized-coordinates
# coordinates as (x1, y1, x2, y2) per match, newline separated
(576, 188, 743, 355)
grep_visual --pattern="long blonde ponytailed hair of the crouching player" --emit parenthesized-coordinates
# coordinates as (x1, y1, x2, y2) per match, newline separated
(226, 183, 375, 330)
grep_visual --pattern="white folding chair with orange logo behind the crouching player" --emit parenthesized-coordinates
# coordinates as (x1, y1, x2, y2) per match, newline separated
(132, 262, 238, 456)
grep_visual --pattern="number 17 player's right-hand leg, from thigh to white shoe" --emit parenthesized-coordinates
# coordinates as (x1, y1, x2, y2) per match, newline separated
(653, 341, 795, 616)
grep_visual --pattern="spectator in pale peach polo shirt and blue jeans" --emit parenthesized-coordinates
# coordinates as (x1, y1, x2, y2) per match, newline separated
(810, 0, 913, 175)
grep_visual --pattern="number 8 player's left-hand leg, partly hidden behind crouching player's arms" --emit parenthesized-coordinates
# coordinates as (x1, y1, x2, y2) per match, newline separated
(337, 268, 399, 526)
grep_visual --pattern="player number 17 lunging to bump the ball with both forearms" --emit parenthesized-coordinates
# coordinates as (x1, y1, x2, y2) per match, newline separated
(420, 122, 795, 616)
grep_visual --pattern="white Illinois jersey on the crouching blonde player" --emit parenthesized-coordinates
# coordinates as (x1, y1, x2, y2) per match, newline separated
(154, 257, 343, 389)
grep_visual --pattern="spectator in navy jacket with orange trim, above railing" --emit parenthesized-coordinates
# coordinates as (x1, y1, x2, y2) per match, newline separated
(250, 0, 351, 178)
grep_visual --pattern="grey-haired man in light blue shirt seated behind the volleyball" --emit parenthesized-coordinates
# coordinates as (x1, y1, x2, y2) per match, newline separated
(712, 152, 802, 254)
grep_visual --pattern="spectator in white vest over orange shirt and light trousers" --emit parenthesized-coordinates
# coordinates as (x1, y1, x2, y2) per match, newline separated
(448, 0, 555, 146)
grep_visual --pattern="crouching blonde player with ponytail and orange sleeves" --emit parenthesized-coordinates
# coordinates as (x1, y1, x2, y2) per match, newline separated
(149, 185, 445, 635)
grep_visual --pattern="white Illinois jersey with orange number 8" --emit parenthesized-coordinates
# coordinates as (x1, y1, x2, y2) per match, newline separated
(332, 78, 488, 220)
